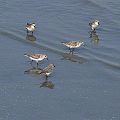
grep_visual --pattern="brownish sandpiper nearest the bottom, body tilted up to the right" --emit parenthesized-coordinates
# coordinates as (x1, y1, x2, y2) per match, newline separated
(40, 64, 55, 79)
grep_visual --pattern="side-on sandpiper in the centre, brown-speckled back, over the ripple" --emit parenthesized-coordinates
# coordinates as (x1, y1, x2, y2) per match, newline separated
(62, 41, 84, 52)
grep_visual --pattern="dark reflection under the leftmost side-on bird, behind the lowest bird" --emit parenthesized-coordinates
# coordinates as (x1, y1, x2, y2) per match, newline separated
(24, 67, 42, 75)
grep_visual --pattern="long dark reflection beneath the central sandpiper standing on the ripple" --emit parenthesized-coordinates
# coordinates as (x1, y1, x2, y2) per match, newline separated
(61, 51, 86, 64)
